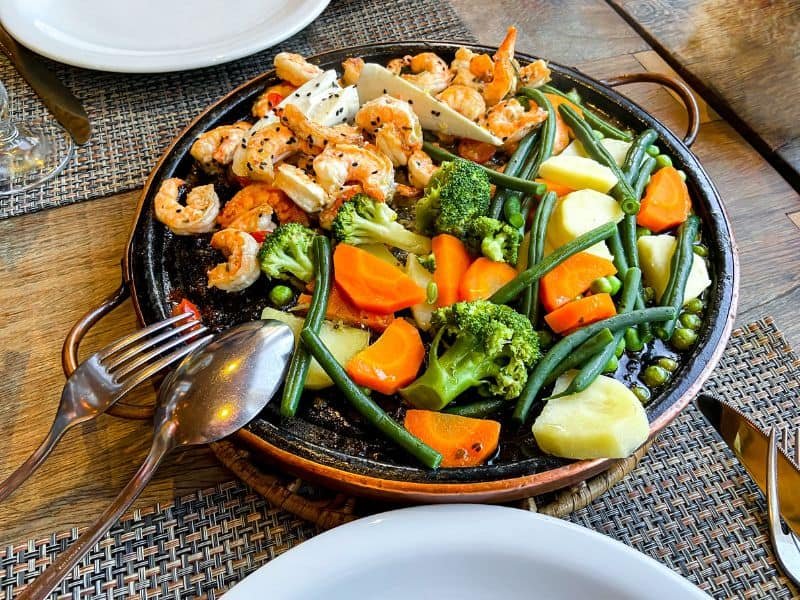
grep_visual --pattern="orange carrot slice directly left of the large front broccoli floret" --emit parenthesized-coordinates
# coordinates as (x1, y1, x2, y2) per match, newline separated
(345, 319, 425, 394)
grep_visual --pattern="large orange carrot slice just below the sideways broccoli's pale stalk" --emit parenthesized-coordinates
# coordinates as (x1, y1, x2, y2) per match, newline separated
(333, 244, 425, 314)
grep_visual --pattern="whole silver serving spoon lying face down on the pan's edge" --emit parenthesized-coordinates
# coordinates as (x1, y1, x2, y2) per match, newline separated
(17, 320, 294, 600)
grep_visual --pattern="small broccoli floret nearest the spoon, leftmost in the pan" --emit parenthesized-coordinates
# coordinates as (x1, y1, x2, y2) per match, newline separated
(258, 223, 316, 283)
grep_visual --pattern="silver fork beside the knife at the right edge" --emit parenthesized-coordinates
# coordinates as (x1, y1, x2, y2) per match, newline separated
(767, 427, 800, 586)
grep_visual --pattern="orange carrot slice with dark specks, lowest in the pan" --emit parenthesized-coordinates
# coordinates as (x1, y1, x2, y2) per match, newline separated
(403, 409, 500, 467)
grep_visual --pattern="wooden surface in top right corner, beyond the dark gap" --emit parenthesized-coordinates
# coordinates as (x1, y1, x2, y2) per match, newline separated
(609, 0, 800, 189)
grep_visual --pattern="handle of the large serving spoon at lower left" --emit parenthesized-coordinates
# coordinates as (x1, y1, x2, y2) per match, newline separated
(17, 425, 174, 600)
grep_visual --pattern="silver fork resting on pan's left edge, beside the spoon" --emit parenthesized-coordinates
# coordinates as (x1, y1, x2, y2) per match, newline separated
(0, 312, 214, 501)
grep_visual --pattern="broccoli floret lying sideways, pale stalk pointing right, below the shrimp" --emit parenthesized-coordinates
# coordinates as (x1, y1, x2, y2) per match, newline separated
(331, 194, 431, 254)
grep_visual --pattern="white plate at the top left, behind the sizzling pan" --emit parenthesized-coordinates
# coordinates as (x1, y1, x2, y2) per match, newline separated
(0, 0, 330, 73)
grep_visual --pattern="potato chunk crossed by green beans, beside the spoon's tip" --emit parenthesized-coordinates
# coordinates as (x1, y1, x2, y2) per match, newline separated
(261, 306, 369, 390)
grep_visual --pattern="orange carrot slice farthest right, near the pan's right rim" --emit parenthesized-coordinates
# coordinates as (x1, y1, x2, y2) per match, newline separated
(636, 167, 692, 233)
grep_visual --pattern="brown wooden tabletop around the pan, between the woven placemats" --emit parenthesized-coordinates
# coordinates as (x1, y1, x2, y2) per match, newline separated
(0, 0, 800, 543)
